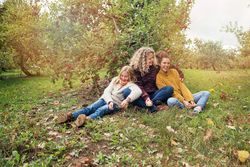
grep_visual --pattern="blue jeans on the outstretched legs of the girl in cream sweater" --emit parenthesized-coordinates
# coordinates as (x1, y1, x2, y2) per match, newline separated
(72, 99, 119, 119)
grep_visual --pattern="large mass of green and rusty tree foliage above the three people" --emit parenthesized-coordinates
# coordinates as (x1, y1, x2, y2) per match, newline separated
(1, 0, 192, 83)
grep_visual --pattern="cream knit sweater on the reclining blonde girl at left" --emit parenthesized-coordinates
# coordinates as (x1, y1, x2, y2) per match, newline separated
(101, 77, 142, 107)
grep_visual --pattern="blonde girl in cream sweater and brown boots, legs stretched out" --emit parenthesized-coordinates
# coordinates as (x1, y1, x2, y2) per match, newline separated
(57, 66, 142, 127)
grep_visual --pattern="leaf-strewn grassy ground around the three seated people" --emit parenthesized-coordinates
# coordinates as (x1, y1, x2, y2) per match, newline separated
(0, 70, 250, 166)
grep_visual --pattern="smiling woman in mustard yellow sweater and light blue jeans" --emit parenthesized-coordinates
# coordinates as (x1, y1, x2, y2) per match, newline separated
(156, 51, 210, 114)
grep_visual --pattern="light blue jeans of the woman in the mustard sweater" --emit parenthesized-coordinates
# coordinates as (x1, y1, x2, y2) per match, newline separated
(167, 91, 210, 109)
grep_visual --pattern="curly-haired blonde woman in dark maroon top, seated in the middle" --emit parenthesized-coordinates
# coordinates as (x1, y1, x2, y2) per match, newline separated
(127, 47, 184, 112)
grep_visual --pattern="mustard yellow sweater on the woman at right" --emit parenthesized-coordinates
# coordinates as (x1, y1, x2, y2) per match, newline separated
(156, 69, 194, 102)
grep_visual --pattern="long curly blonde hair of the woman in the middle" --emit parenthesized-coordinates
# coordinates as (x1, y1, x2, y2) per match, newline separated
(130, 47, 157, 76)
